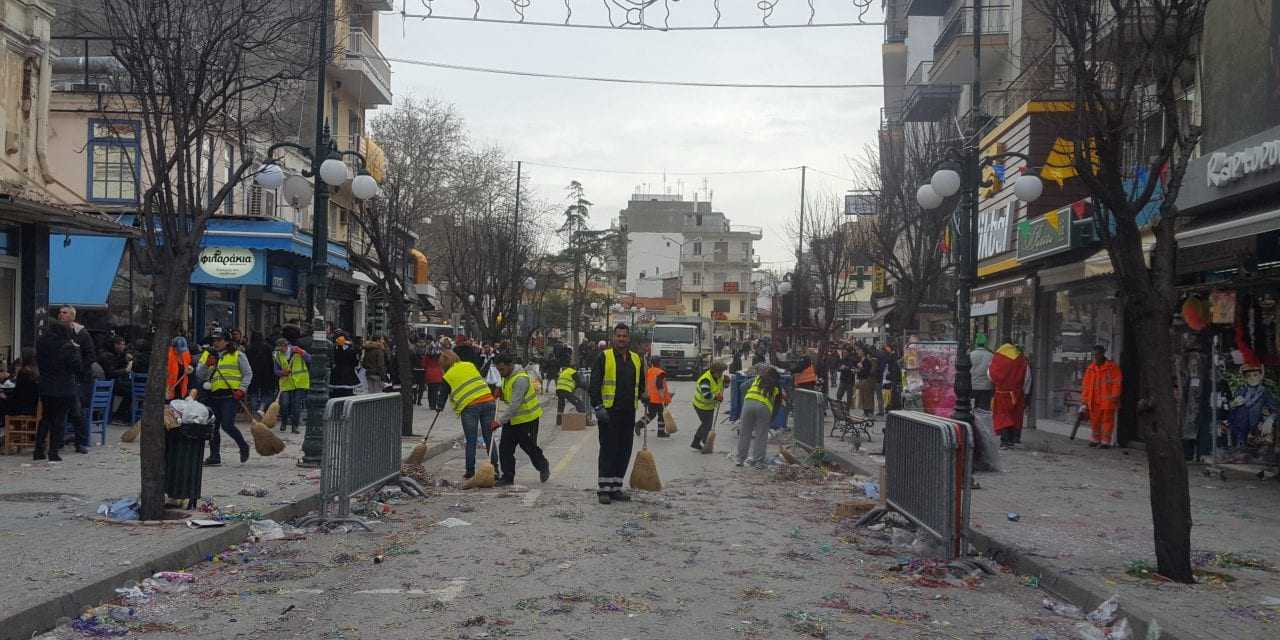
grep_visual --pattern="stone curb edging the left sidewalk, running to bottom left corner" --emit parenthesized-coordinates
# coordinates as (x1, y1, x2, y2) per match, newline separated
(0, 438, 458, 637)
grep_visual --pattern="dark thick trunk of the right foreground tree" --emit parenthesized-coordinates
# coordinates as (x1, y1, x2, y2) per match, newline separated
(1134, 298, 1196, 584)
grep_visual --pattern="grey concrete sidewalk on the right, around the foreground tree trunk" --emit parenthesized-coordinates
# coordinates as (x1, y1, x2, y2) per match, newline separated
(827, 422, 1280, 640)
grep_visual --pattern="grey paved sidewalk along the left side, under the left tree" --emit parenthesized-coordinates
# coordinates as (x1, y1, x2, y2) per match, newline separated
(0, 399, 473, 624)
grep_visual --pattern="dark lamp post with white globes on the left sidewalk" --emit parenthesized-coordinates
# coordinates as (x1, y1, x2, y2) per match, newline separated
(256, 0, 379, 467)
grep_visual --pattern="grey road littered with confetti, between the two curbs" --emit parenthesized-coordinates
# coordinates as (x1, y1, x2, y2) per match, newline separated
(47, 383, 1090, 640)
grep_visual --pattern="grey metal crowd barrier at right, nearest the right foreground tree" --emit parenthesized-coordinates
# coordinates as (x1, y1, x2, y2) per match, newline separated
(858, 411, 973, 559)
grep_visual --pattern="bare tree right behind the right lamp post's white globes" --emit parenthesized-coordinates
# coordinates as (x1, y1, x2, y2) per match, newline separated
(851, 123, 955, 337)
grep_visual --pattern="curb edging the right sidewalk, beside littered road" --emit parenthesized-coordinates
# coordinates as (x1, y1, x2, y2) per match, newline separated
(826, 449, 1201, 640)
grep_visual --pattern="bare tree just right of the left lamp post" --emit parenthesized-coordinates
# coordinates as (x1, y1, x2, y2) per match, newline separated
(352, 96, 463, 435)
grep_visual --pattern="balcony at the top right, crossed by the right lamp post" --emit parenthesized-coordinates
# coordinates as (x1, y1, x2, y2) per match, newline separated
(933, 5, 1010, 82)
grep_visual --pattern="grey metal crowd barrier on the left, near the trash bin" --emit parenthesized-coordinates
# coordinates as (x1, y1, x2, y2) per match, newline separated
(301, 393, 426, 531)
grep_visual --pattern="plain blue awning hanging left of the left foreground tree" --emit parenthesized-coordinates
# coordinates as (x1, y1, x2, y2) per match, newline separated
(49, 236, 125, 307)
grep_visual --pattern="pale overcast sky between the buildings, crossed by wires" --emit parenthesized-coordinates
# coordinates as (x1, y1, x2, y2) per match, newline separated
(381, 0, 883, 266)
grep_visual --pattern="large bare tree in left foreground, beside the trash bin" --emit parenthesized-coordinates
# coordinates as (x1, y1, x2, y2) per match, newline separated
(77, 0, 317, 518)
